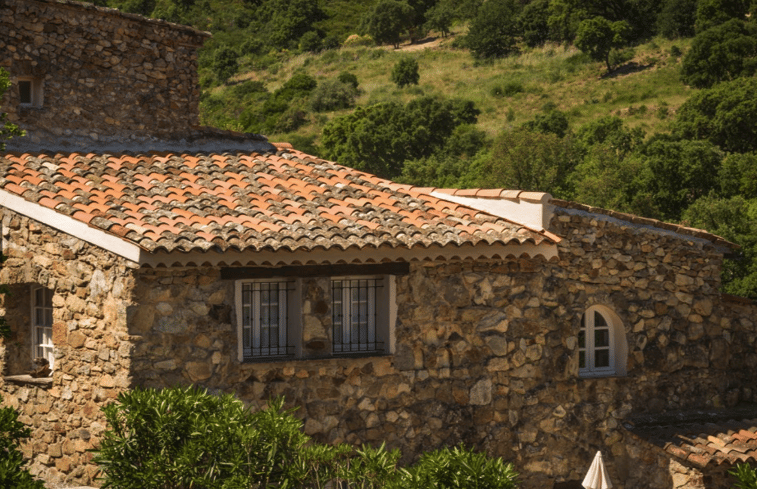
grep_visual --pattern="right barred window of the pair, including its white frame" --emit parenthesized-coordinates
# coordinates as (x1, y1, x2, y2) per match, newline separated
(331, 275, 396, 355)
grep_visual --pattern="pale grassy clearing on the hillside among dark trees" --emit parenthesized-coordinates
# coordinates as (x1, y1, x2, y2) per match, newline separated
(202, 28, 691, 148)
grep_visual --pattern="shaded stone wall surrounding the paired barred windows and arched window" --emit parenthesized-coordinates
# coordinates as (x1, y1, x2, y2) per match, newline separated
(130, 208, 757, 488)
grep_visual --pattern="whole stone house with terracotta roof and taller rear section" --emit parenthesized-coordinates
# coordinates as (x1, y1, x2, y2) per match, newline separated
(0, 0, 757, 488)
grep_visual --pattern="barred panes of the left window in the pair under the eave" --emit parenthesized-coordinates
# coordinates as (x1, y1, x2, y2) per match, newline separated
(239, 281, 292, 359)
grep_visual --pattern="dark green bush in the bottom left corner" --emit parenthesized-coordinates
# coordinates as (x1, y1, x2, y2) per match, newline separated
(0, 397, 45, 489)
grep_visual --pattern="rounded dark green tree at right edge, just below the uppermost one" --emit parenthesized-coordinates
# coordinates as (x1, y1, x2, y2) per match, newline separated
(673, 78, 757, 153)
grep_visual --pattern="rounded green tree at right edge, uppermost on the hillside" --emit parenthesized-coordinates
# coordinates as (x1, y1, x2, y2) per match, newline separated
(681, 19, 757, 88)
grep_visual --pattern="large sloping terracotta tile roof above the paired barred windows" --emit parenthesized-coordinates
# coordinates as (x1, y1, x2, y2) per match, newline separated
(0, 145, 558, 252)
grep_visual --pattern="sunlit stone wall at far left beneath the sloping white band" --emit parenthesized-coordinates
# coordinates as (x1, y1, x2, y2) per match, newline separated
(0, 210, 133, 485)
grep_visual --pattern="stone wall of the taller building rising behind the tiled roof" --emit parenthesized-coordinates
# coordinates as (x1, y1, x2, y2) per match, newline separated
(0, 0, 206, 139)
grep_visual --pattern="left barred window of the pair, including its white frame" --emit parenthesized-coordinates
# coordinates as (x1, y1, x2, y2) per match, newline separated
(235, 279, 298, 361)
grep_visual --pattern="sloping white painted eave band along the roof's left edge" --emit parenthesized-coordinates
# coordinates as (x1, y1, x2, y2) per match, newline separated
(0, 189, 147, 264)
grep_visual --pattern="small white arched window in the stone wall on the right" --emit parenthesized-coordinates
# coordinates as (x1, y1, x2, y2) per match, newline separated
(578, 306, 628, 377)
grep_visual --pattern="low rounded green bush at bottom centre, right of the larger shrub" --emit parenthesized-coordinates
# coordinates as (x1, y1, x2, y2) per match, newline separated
(395, 447, 518, 489)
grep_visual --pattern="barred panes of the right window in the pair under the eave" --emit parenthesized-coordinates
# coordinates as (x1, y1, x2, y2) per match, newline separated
(331, 277, 384, 354)
